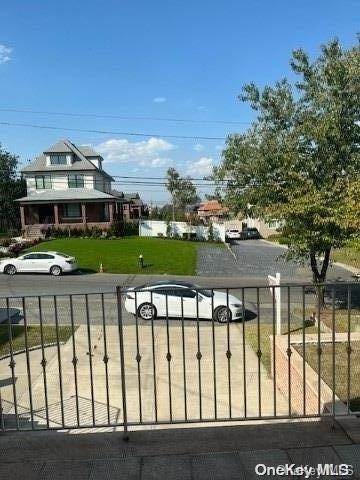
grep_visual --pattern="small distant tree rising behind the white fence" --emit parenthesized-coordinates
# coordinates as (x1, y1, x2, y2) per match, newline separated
(166, 167, 199, 221)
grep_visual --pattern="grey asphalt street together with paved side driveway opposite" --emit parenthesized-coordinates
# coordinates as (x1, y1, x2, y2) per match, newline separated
(0, 240, 352, 324)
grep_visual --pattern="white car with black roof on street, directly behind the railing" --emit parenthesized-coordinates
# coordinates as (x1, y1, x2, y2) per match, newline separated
(125, 281, 243, 323)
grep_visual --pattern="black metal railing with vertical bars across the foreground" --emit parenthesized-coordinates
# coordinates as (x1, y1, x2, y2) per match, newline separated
(0, 283, 360, 433)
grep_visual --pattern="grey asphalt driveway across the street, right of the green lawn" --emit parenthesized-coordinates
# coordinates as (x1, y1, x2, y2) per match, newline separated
(197, 240, 352, 283)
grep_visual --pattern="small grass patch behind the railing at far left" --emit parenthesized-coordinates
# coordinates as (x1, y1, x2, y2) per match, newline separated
(0, 325, 72, 357)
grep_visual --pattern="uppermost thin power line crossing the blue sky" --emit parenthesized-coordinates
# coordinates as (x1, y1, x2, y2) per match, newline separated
(0, 108, 251, 125)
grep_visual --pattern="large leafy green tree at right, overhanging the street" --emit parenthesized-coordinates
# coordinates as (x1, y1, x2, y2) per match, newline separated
(215, 40, 360, 283)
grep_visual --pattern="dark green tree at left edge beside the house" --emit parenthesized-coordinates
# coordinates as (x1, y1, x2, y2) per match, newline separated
(0, 145, 26, 232)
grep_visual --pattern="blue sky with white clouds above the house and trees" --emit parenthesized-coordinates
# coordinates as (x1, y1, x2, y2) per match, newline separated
(0, 0, 360, 202)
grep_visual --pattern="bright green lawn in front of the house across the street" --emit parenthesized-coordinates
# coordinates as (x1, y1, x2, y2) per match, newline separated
(31, 237, 223, 275)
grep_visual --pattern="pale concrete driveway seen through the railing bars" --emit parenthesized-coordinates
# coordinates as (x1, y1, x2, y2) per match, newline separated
(0, 323, 288, 428)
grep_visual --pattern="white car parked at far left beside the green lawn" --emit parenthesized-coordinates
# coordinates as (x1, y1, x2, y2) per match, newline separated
(0, 252, 78, 276)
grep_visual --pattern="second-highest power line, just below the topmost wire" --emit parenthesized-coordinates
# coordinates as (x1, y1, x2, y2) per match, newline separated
(0, 122, 226, 141)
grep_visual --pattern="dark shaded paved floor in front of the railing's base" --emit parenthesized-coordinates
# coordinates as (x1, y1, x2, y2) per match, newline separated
(0, 419, 360, 480)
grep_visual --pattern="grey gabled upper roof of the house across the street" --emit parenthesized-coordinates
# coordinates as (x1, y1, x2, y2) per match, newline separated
(21, 140, 114, 181)
